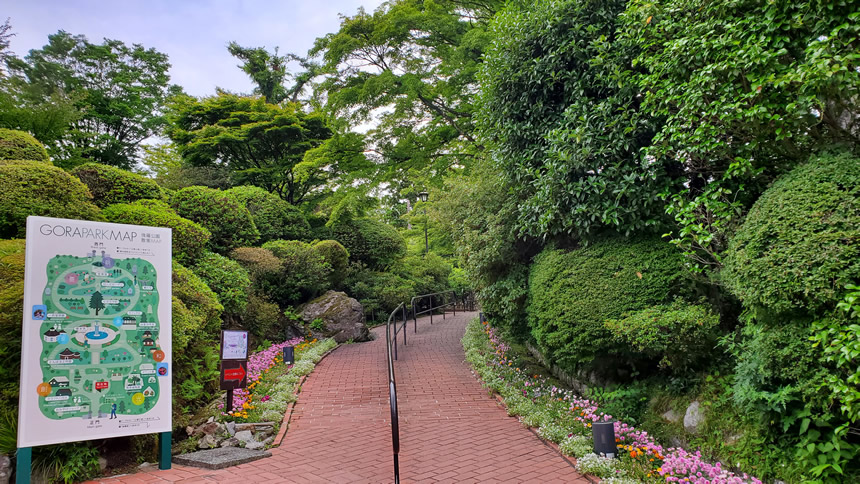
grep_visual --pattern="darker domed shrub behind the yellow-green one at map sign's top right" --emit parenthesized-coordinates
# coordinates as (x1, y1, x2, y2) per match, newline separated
(170, 186, 260, 254)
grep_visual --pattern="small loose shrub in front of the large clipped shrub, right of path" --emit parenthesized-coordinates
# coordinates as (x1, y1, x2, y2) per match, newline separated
(605, 299, 720, 370)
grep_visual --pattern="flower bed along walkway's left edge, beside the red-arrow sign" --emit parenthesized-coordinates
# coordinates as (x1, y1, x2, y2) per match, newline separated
(221, 338, 337, 423)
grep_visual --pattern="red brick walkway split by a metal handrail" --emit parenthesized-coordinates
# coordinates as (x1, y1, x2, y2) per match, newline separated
(87, 312, 588, 484)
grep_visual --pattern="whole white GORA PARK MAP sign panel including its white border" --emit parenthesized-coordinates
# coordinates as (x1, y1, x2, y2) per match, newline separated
(18, 217, 173, 447)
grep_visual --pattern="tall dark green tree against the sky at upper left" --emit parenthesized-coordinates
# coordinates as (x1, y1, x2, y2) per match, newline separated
(7, 30, 179, 169)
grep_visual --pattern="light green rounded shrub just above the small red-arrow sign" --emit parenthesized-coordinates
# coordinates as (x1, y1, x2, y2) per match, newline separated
(193, 252, 251, 316)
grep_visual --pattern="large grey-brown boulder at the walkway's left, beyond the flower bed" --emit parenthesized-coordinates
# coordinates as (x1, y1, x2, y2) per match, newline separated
(299, 291, 370, 343)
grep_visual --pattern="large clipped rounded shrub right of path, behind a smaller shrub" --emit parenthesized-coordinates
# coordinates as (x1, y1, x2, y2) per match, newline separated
(528, 238, 682, 369)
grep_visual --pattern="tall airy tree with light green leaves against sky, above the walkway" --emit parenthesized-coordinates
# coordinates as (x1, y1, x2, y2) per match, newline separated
(310, 0, 502, 186)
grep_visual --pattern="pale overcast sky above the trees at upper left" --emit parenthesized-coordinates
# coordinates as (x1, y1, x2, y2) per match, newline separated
(0, 0, 382, 96)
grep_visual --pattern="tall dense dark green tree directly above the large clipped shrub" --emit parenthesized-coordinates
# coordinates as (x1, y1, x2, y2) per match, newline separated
(479, 0, 677, 237)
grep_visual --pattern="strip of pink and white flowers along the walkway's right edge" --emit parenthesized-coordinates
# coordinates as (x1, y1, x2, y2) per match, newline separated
(463, 320, 761, 484)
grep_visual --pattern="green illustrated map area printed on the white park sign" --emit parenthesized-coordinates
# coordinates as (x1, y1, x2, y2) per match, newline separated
(33, 250, 169, 420)
